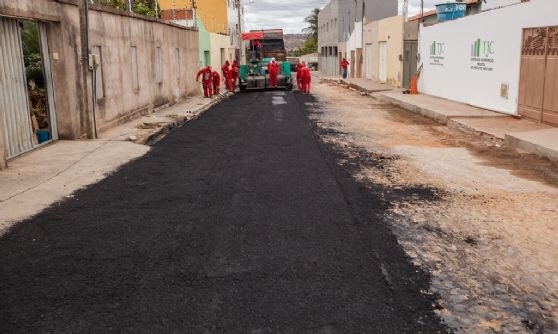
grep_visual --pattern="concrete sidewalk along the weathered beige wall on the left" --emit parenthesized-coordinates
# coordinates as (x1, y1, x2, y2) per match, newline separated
(0, 97, 222, 235)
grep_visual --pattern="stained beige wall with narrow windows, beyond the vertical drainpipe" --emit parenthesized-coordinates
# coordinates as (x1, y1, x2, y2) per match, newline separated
(90, 7, 198, 129)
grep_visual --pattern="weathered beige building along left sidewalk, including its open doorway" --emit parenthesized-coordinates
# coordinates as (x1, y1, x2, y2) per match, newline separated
(0, 0, 198, 165)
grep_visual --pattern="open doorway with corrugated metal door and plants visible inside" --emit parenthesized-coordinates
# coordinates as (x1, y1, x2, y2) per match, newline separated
(0, 17, 58, 159)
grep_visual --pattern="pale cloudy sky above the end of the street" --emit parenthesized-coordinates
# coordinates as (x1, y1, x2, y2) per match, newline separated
(241, 0, 445, 34)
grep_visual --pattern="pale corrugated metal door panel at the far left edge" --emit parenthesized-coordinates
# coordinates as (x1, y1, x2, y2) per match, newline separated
(0, 17, 33, 158)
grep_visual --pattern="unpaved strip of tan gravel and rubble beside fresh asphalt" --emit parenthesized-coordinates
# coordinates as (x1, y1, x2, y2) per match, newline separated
(309, 82, 558, 333)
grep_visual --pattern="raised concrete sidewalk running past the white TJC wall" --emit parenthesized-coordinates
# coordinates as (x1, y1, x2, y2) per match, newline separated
(312, 72, 558, 161)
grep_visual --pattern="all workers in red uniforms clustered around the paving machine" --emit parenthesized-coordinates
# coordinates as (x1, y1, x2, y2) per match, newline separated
(196, 58, 312, 97)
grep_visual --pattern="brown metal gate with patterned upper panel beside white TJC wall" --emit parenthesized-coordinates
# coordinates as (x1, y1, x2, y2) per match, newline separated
(519, 26, 558, 125)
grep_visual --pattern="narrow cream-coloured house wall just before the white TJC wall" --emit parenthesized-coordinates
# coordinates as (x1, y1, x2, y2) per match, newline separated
(378, 16, 404, 87)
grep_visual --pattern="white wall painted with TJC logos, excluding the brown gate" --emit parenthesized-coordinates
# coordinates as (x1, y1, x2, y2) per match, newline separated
(419, 0, 558, 114)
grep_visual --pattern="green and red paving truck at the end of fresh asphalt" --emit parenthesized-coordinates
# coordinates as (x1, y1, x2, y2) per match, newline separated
(240, 29, 293, 90)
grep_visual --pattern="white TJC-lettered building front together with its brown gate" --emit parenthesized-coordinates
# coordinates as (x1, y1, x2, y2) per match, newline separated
(419, 0, 558, 124)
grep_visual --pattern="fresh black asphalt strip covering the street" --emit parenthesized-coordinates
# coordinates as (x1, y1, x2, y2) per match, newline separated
(0, 91, 447, 334)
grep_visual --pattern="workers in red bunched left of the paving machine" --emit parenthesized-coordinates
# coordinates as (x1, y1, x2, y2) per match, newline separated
(196, 60, 239, 97)
